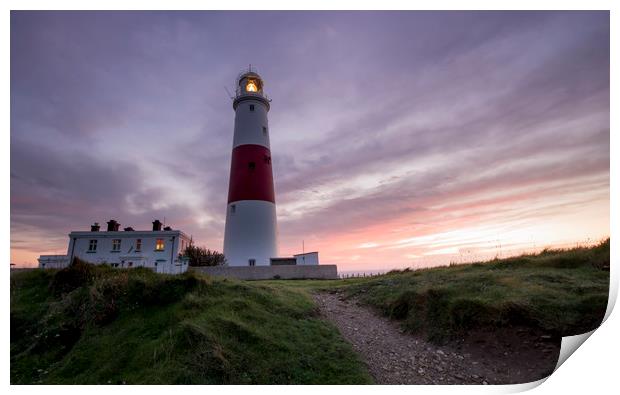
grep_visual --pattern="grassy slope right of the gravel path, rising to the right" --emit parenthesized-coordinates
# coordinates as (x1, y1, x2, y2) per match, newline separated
(344, 239, 609, 341)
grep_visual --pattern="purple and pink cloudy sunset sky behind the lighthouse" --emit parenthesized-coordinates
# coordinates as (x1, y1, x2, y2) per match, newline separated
(10, 11, 610, 271)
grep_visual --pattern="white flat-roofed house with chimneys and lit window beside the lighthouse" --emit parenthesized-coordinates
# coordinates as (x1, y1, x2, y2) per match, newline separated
(39, 220, 190, 274)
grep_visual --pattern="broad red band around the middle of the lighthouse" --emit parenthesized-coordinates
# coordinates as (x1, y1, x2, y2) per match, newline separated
(228, 144, 276, 203)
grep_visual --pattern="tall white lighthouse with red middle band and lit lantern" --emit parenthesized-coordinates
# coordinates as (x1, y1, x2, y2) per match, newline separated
(224, 68, 278, 266)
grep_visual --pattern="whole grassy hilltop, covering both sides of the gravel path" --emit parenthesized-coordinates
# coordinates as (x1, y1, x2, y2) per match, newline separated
(11, 240, 609, 384)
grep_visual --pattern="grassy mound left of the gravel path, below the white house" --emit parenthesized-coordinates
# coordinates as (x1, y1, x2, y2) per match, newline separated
(11, 262, 371, 384)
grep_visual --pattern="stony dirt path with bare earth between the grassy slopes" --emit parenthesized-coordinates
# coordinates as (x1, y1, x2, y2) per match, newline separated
(313, 293, 559, 384)
